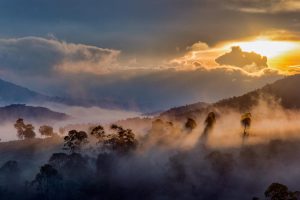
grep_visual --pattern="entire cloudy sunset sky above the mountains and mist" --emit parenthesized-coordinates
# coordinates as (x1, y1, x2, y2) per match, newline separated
(0, 0, 300, 111)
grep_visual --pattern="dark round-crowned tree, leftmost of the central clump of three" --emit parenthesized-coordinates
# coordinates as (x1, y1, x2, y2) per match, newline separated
(64, 130, 88, 153)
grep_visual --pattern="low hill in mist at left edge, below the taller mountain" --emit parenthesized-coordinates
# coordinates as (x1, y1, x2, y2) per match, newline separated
(0, 104, 69, 123)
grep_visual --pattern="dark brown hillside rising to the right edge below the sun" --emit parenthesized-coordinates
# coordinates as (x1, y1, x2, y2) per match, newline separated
(160, 75, 300, 118)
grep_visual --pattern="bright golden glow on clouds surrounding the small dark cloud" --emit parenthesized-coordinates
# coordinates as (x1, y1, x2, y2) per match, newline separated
(171, 30, 300, 74)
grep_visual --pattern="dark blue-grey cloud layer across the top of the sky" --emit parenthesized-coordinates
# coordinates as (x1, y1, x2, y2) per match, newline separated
(0, 0, 299, 61)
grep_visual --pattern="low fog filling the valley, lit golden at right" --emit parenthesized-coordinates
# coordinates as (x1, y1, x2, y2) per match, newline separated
(0, 97, 300, 200)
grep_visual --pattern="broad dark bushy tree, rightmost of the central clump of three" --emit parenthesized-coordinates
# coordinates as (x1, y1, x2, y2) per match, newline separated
(104, 124, 138, 153)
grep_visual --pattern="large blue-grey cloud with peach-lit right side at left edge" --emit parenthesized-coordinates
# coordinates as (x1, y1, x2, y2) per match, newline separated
(0, 37, 120, 76)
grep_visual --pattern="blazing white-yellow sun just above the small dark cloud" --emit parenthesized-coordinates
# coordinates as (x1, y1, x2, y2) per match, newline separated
(230, 39, 297, 58)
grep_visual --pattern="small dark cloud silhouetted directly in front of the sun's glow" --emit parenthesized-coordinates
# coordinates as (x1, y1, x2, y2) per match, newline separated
(216, 46, 268, 73)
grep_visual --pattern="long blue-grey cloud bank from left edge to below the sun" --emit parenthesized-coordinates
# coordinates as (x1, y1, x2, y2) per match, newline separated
(0, 37, 280, 112)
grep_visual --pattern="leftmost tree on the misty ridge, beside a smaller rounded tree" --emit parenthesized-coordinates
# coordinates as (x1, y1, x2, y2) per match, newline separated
(14, 118, 35, 139)
